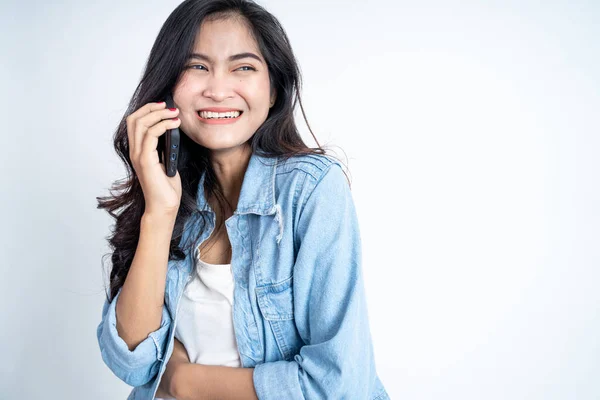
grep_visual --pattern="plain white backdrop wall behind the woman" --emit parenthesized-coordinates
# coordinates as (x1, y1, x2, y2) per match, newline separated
(0, 0, 600, 400)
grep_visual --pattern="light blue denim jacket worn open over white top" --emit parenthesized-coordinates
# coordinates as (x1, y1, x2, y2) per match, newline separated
(97, 154, 389, 400)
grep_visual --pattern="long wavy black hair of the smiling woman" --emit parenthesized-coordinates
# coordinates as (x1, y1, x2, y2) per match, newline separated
(96, 0, 346, 301)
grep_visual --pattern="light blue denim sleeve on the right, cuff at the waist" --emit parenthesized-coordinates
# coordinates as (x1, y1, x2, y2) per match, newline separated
(253, 164, 377, 400)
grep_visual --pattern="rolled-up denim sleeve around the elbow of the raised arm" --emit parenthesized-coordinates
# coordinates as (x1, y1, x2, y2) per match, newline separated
(96, 289, 171, 386)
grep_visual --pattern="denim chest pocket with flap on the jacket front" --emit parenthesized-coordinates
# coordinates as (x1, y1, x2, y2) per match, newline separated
(256, 277, 303, 361)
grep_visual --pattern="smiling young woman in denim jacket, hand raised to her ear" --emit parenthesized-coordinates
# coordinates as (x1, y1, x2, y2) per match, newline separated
(97, 0, 389, 400)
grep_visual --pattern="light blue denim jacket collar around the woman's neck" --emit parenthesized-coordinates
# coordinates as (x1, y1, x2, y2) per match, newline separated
(196, 152, 278, 215)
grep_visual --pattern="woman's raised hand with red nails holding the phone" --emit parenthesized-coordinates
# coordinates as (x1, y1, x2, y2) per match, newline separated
(126, 102, 181, 215)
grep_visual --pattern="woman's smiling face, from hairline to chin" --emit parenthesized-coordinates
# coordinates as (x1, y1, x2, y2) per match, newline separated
(173, 19, 275, 152)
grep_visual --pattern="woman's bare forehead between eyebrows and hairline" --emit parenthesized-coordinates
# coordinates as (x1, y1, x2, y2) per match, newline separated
(194, 18, 258, 54)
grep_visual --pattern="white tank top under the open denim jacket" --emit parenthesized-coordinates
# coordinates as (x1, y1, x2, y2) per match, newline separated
(155, 251, 241, 400)
